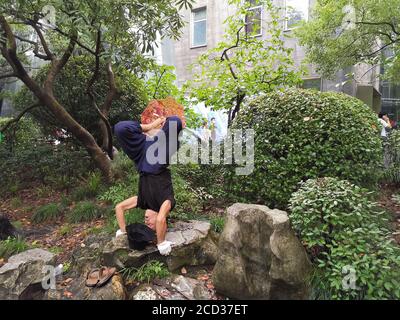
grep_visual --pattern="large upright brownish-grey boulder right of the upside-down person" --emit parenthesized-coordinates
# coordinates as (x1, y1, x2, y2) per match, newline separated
(213, 203, 311, 299)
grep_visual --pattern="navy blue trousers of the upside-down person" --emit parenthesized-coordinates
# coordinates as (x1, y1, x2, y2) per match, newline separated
(114, 116, 182, 174)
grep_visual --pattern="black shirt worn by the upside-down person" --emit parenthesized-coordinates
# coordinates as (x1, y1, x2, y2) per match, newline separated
(137, 169, 175, 212)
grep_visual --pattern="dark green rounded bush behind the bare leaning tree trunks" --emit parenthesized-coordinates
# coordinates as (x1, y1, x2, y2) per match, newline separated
(14, 56, 148, 141)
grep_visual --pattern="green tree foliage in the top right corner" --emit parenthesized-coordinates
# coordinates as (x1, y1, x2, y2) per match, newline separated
(296, 0, 400, 82)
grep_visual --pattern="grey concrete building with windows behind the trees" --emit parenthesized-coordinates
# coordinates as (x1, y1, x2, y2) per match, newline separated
(164, 0, 400, 120)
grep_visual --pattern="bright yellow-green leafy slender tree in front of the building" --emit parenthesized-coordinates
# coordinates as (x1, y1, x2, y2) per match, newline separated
(185, 0, 300, 119)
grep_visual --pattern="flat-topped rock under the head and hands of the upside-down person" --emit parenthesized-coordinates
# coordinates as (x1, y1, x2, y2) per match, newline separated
(102, 221, 218, 271)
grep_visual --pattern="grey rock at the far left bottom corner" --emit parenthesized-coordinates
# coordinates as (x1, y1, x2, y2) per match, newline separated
(0, 249, 55, 300)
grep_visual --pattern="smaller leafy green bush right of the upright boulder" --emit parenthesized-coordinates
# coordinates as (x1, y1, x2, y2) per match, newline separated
(290, 178, 400, 299)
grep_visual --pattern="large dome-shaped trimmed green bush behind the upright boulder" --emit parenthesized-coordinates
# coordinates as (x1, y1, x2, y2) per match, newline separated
(225, 89, 383, 209)
